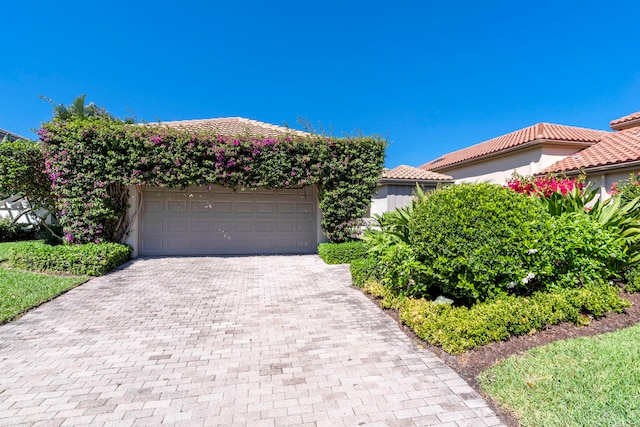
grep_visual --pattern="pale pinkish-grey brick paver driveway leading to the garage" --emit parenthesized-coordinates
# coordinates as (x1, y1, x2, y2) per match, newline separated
(0, 255, 500, 427)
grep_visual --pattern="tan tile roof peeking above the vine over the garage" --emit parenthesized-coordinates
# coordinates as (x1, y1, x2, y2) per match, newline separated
(151, 117, 310, 137)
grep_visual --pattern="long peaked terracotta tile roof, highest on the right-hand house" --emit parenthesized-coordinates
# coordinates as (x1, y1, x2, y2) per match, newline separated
(420, 123, 607, 170)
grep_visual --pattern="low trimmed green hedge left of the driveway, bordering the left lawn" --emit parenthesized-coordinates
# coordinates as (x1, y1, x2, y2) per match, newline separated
(9, 242, 131, 276)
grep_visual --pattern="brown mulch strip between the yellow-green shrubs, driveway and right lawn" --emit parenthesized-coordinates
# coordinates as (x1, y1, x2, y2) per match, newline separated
(364, 293, 640, 427)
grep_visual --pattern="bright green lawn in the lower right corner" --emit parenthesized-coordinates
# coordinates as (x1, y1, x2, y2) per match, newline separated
(478, 325, 640, 427)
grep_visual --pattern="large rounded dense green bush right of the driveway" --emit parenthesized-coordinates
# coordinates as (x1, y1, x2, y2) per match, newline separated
(410, 183, 550, 303)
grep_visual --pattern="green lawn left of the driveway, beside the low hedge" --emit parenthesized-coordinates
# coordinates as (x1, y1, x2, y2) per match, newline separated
(0, 242, 88, 324)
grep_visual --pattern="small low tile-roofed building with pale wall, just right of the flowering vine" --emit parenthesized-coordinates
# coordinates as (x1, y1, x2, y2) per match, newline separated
(369, 165, 453, 216)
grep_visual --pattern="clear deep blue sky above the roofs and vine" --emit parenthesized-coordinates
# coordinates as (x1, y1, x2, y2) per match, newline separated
(0, 0, 640, 167)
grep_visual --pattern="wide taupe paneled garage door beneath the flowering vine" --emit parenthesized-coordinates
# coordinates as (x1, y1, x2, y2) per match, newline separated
(139, 187, 318, 255)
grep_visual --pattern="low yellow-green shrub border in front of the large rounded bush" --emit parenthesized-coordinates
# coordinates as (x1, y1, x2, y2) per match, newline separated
(400, 285, 630, 354)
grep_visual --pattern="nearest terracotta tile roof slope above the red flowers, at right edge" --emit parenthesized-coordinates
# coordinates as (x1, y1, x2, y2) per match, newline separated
(540, 128, 640, 174)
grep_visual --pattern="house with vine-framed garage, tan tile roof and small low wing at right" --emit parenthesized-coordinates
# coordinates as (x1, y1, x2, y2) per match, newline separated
(126, 117, 436, 257)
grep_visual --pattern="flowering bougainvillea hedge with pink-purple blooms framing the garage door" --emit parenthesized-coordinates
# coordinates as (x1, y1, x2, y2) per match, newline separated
(39, 118, 386, 243)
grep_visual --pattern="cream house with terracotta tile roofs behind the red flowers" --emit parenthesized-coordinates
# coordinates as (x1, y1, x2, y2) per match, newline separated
(419, 112, 640, 197)
